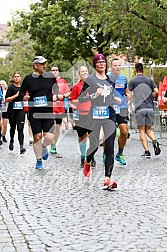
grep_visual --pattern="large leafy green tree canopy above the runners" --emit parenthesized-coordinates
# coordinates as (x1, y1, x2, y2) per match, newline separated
(10, 0, 167, 64)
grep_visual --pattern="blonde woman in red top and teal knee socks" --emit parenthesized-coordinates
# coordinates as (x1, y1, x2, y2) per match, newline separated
(70, 66, 96, 168)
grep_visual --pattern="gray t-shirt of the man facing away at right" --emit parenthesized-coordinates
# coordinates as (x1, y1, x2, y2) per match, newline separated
(128, 74, 157, 111)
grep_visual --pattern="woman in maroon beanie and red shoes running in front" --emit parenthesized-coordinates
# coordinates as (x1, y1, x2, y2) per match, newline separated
(73, 54, 120, 189)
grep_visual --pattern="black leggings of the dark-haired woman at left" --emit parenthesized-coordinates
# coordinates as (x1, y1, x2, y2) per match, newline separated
(8, 109, 25, 146)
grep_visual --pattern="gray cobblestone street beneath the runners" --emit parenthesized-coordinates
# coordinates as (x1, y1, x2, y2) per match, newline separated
(0, 121, 167, 252)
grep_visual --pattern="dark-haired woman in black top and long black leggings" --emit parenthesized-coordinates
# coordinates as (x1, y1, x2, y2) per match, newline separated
(5, 72, 26, 154)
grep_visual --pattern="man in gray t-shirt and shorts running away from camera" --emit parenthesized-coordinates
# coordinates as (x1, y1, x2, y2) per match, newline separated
(128, 63, 161, 158)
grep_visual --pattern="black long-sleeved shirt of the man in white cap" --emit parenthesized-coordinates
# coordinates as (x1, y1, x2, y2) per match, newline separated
(20, 72, 59, 112)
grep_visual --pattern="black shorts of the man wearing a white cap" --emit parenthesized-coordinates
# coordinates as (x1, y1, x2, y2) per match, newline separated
(29, 112, 54, 135)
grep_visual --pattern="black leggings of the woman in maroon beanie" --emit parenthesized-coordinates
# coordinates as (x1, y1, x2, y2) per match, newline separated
(87, 120, 116, 177)
